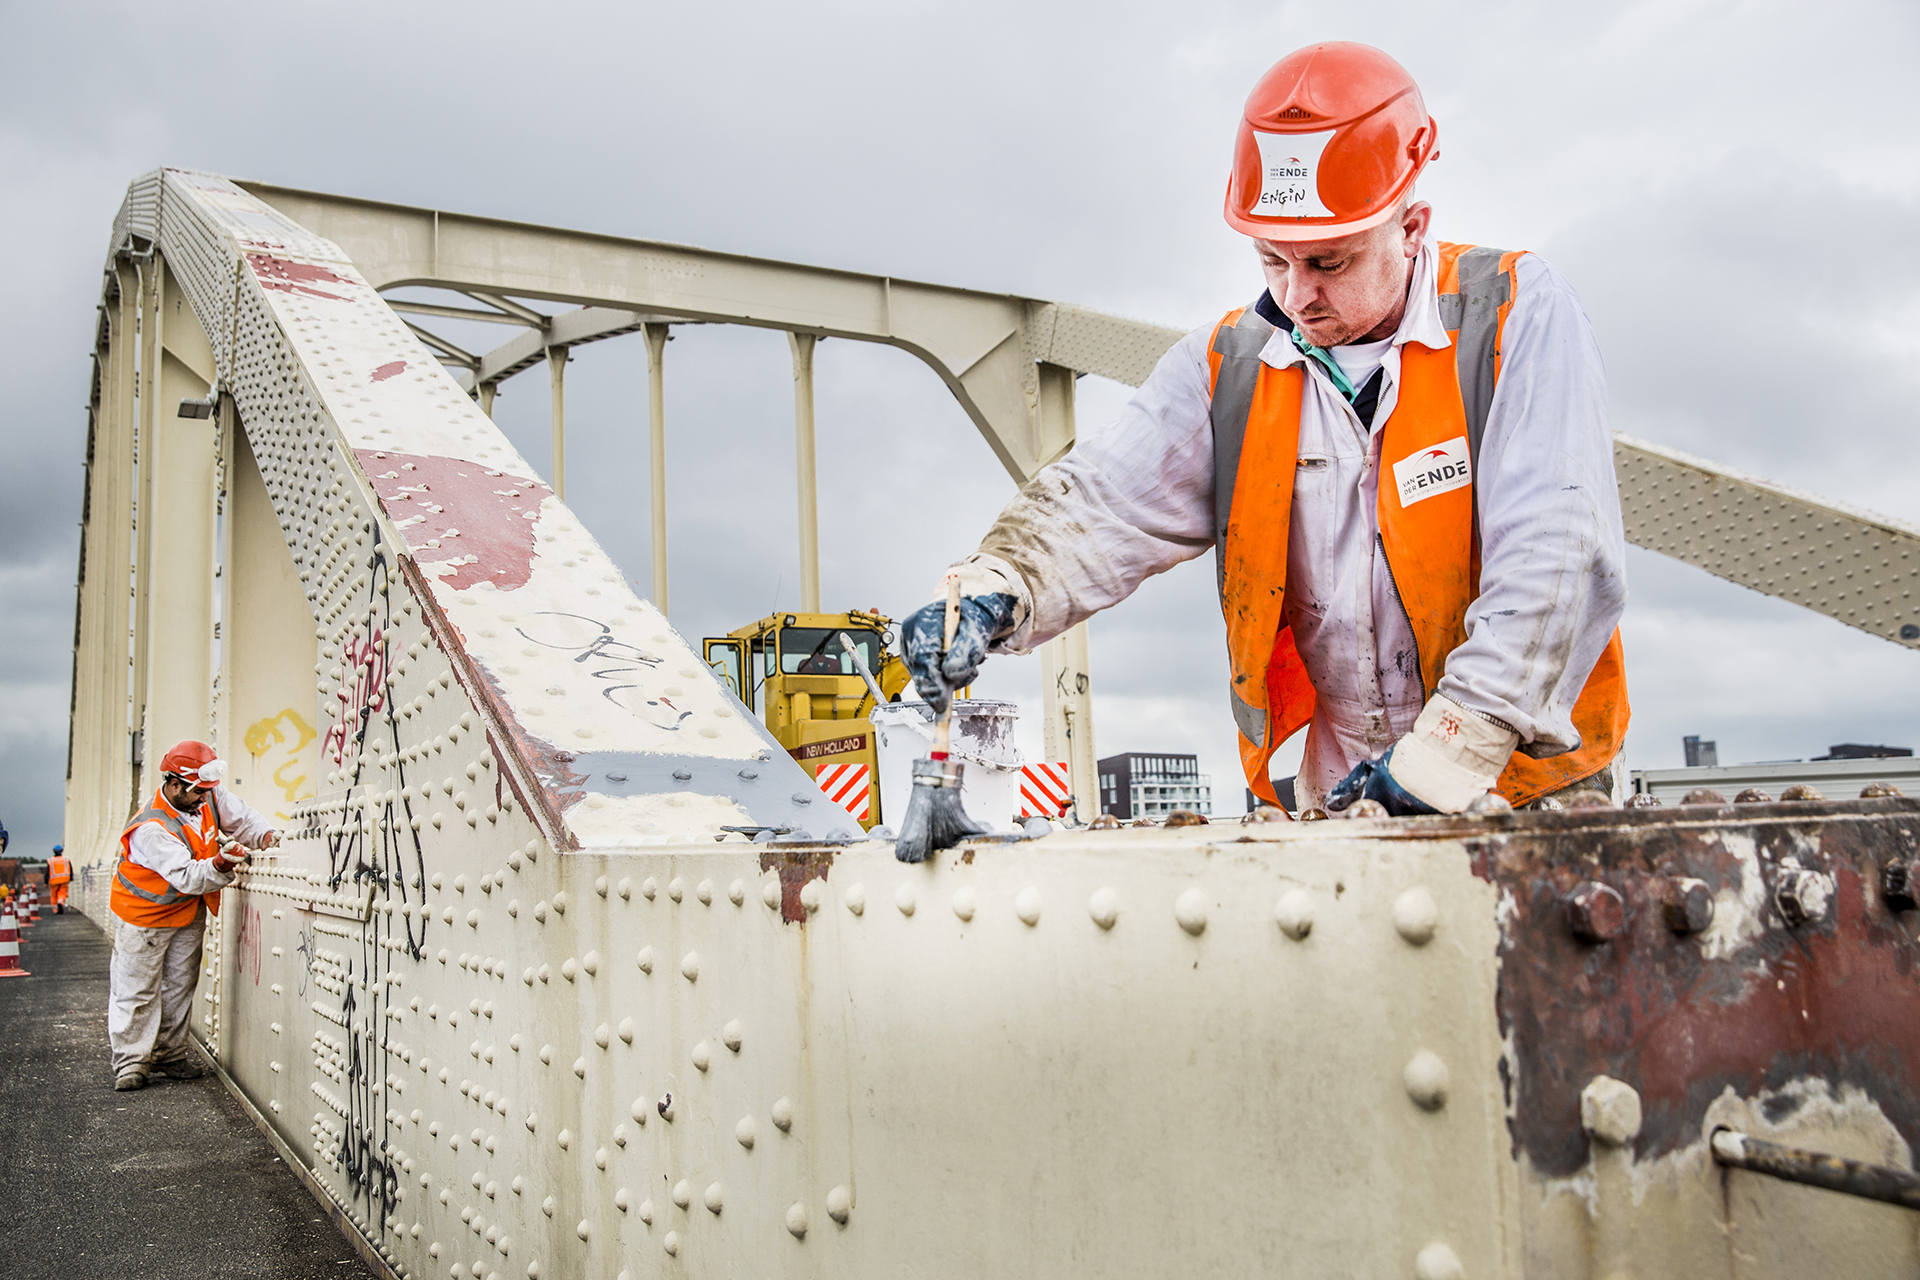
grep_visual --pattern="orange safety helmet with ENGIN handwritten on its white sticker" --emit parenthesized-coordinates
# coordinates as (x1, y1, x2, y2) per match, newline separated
(1227, 40, 1440, 240)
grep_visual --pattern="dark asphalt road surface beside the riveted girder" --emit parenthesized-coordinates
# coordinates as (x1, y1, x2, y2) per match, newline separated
(0, 913, 372, 1280)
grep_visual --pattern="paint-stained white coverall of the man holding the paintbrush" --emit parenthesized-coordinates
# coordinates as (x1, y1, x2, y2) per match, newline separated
(958, 240, 1626, 808)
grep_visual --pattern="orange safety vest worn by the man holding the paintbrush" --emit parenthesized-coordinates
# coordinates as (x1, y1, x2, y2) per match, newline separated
(1208, 244, 1628, 804)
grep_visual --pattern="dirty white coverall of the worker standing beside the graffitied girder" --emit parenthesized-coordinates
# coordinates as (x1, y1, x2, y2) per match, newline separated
(108, 787, 273, 1079)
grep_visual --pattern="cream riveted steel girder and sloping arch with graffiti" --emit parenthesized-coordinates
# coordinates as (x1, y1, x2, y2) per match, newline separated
(65, 171, 1920, 1280)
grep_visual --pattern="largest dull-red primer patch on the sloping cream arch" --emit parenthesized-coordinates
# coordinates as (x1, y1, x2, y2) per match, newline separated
(355, 449, 553, 591)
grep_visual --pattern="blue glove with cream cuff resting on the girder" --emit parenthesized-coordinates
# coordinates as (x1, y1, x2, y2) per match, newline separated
(1327, 693, 1521, 818)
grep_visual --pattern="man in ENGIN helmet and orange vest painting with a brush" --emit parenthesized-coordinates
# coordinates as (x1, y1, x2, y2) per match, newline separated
(902, 44, 1628, 816)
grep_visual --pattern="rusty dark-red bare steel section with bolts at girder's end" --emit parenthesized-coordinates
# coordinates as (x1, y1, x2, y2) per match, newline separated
(1428, 798, 1920, 1176)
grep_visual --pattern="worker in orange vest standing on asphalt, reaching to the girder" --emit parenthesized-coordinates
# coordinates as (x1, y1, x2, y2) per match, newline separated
(108, 741, 278, 1090)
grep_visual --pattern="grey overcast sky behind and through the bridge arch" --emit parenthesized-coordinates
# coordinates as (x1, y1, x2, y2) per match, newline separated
(0, 0, 1920, 852)
